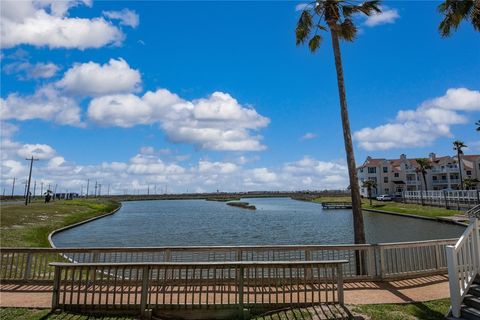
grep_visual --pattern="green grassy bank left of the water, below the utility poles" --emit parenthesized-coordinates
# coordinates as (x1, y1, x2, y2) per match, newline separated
(0, 199, 120, 247)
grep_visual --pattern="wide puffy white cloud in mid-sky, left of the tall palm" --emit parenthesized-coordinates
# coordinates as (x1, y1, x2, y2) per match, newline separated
(88, 89, 269, 151)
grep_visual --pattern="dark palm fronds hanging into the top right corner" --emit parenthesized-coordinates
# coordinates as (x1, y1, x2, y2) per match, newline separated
(438, 0, 480, 37)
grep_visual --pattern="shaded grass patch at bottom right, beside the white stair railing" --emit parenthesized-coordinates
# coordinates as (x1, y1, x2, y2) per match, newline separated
(349, 299, 450, 320)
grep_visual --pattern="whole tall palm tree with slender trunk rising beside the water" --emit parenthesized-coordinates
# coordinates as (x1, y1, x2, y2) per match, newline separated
(295, 0, 381, 243)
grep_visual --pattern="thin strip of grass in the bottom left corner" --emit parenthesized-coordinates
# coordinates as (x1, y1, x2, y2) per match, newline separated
(0, 308, 134, 320)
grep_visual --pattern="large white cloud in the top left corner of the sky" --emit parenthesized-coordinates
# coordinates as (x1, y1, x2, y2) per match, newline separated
(0, 0, 124, 49)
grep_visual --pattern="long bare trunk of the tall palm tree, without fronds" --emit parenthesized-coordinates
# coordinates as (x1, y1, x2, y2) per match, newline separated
(330, 24, 365, 243)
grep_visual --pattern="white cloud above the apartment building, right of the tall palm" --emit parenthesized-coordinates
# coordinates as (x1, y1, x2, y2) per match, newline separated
(354, 88, 480, 151)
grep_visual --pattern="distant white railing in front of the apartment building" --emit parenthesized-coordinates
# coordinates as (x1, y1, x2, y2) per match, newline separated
(402, 190, 480, 210)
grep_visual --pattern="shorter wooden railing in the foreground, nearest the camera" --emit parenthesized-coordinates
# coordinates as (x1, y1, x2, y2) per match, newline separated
(51, 260, 347, 314)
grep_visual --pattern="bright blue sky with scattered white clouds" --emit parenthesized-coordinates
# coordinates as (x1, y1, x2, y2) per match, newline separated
(1, 1, 480, 193)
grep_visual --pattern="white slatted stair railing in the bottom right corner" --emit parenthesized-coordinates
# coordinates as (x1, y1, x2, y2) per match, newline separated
(446, 219, 480, 318)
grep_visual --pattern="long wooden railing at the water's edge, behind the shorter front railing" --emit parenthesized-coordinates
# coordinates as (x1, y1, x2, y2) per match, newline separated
(0, 239, 457, 283)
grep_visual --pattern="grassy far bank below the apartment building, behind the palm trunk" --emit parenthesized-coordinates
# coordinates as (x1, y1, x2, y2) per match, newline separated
(313, 197, 459, 217)
